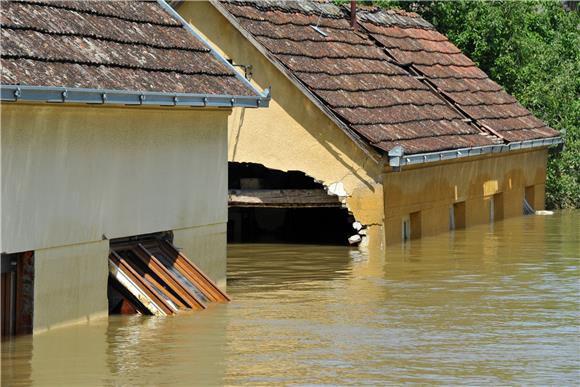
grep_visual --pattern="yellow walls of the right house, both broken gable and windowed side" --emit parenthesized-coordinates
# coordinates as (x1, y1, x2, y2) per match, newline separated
(178, 2, 547, 247)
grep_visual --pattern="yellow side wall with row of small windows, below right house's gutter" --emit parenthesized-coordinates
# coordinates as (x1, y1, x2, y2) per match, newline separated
(384, 148, 548, 243)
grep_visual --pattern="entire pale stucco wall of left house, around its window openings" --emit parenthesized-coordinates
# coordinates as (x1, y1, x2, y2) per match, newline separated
(0, 104, 231, 333)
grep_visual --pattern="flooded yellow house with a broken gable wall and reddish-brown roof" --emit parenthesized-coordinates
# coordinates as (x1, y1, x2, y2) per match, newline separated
(173, 0, 561, 245)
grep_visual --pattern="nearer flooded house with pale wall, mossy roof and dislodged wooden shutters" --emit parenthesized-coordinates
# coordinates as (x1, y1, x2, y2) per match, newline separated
(0, 1, 269, 336)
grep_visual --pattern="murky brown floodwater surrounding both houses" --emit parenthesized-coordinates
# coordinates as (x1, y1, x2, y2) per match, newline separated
(2, 211, 580, 386)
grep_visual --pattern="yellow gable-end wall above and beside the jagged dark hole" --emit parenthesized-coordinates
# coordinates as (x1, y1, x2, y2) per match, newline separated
(177, 2, 383, 246)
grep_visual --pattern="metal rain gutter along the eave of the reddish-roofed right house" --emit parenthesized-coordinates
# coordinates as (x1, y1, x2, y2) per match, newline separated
(388, 137, 563, 170)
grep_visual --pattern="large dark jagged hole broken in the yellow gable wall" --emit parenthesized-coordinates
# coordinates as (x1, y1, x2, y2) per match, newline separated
(228, 162, 355, 245)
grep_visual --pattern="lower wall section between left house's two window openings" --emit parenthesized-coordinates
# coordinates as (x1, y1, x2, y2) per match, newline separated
(33, 241, 109, 334)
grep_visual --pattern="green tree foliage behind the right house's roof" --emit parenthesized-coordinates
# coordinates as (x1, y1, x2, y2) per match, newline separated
(346, 0, 580, 208)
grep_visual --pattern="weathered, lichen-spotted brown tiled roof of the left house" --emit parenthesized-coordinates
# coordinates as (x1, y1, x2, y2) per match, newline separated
(0, 1, 256, 96)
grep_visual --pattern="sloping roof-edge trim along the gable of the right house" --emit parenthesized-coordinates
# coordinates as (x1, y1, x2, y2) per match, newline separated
(204, 0, 384, 164)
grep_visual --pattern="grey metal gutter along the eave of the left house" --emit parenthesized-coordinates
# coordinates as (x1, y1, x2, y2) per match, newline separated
(0, 85, 269, 108)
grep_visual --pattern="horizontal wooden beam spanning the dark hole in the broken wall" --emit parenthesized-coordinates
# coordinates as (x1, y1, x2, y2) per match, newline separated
(228, 189, 342, 208)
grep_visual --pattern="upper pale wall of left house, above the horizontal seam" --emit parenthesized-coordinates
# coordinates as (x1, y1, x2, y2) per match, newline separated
(1, 104, 229, 258)
